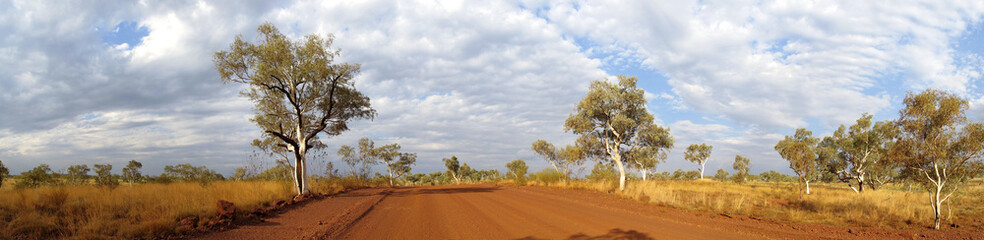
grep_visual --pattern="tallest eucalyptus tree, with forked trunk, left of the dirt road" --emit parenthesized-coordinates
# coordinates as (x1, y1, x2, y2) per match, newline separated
(213, 23, 376, 194)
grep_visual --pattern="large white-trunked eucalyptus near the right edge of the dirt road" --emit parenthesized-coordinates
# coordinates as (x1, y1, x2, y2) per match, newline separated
(564, 75, 673, 191)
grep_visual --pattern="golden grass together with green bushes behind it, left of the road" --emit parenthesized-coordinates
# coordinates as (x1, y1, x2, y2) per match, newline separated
(0, 161, 385, 239)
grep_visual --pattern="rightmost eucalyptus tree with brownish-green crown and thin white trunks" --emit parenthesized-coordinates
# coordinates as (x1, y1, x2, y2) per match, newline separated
(891, 90, 984, 229)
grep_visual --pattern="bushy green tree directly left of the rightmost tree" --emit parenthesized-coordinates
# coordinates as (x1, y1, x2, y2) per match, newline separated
(832, 113, 898, 192)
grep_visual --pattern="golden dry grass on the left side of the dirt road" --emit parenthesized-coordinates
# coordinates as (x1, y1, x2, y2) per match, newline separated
(0, 180, 359, 239)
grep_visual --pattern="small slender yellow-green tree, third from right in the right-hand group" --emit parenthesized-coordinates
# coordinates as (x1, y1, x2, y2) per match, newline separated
(775, 128, 819, 194)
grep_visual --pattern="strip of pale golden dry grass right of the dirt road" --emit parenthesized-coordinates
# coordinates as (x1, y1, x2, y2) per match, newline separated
(531, 180, 984, 229)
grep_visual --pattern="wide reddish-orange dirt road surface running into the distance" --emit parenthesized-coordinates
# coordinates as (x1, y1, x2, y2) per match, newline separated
(201, 185, 984, 239)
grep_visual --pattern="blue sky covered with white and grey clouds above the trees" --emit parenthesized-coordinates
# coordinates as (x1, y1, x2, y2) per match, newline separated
(0, 0, 984, 174)
